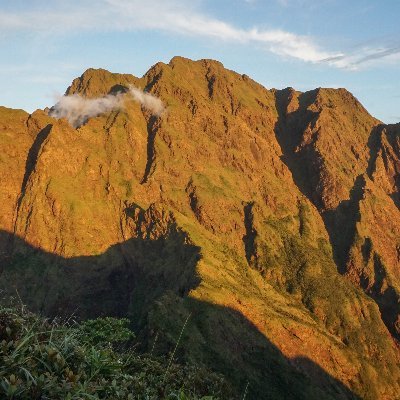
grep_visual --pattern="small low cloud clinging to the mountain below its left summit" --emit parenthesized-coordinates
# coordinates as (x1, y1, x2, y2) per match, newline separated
(49, 86, 164, 128)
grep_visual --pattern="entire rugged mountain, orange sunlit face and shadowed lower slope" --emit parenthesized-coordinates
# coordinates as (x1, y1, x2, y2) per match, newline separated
(0, 57, 400, 400)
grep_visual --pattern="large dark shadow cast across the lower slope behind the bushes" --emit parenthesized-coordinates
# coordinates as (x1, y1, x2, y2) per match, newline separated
(0, 231, 359, 400)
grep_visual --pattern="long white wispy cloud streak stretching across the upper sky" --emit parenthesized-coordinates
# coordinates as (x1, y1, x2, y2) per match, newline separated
(0, 0, 400, 70)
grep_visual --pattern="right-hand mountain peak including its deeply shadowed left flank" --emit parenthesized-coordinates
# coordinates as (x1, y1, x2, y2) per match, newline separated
(276, 85, 400, 339)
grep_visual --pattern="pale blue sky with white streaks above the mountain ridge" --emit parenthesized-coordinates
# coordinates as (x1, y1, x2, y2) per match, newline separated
(0, 0, 400, 123)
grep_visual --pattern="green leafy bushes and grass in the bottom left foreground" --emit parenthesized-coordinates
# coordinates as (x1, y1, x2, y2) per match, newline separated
(0, 306, 227, 400)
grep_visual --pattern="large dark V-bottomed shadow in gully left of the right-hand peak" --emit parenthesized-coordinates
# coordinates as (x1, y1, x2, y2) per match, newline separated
(275, 88, 358, 274)
